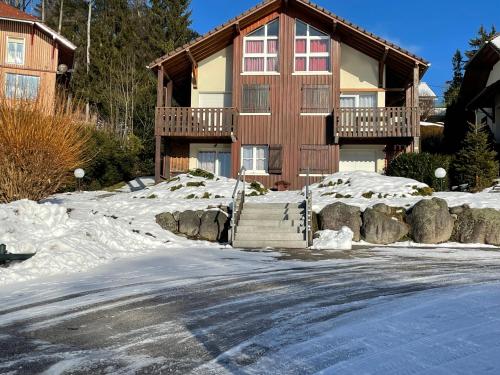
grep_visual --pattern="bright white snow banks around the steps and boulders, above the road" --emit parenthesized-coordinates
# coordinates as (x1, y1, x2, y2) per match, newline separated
(0, 172, 500, 285)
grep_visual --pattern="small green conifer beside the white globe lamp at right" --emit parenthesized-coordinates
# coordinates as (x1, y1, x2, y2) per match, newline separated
(451, 124, 499, 191)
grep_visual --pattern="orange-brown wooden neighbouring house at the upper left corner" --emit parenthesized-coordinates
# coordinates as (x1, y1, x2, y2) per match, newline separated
(0, 3, 76, 102)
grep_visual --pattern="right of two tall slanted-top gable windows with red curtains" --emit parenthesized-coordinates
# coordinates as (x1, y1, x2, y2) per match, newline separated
(295, 20, 330, 72)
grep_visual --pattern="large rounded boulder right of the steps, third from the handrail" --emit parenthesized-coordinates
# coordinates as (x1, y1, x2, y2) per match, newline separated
(408, 198, 455, 244)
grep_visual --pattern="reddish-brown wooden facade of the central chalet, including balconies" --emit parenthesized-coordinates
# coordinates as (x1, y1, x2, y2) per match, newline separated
(151, 0, 427, 188)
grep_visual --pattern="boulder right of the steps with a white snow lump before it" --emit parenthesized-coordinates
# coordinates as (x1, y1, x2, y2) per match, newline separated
(319, 202, 362, 241)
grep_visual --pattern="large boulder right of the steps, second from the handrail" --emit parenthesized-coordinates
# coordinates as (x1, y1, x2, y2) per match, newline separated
(362, 203, 409, 245)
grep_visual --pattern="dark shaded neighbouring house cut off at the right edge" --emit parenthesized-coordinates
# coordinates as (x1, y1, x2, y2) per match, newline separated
(460, 34, 500, 143)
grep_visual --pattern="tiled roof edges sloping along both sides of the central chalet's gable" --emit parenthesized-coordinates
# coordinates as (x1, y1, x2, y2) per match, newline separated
(148, 0, 429, 70)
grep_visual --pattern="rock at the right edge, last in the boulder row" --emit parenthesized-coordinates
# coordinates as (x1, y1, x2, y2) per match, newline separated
(452, 207, 500, 246)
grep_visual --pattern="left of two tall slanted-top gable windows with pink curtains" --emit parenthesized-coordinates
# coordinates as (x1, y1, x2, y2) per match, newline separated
(243, 20, 279, 73)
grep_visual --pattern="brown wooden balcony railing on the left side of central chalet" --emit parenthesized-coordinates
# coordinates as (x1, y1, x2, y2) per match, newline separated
(155, 107, 238, 138)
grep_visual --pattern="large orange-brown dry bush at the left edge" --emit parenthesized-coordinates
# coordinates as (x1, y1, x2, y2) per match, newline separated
(0, 98, 88, 203)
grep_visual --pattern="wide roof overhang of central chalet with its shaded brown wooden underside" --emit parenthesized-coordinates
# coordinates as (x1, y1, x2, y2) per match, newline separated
(148, 0, 430, 86)
